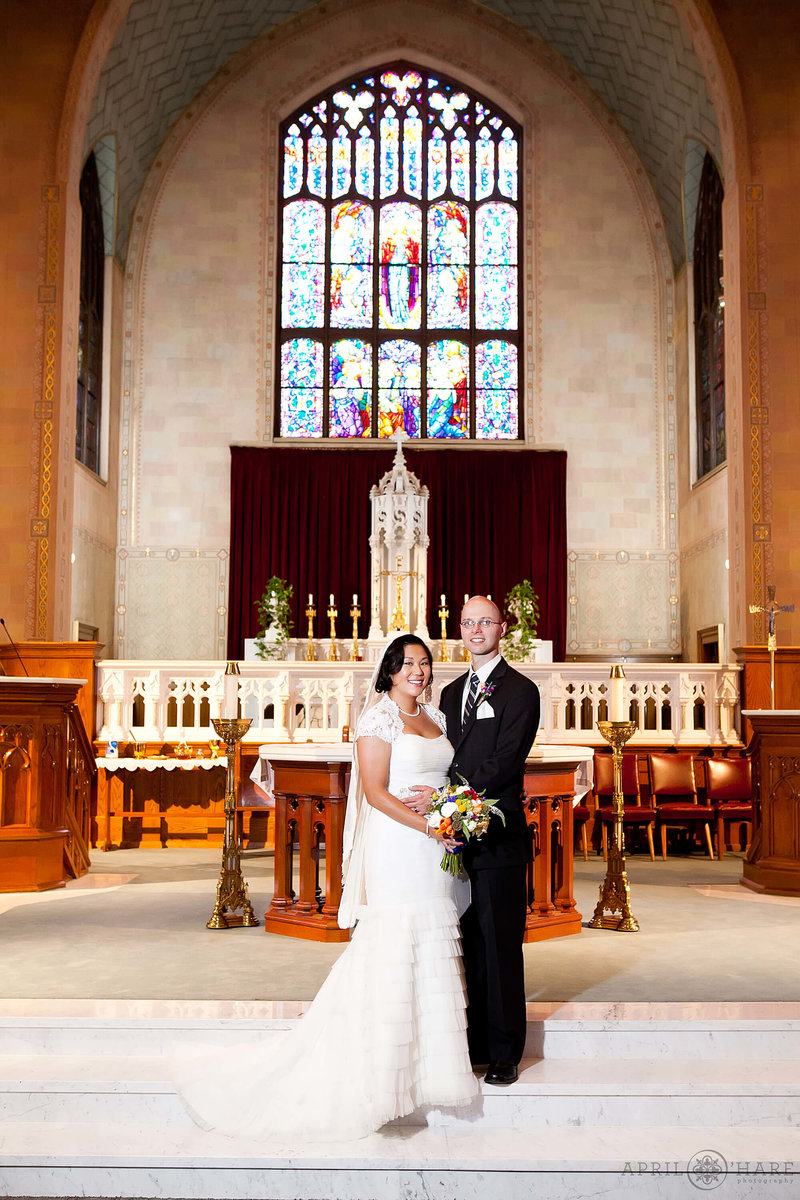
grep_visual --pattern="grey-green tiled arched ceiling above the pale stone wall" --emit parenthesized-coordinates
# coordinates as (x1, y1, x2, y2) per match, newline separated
(85, 0, 722, 268)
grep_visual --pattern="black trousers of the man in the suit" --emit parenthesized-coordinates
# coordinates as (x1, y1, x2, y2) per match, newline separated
(461, 864, 528, 1063)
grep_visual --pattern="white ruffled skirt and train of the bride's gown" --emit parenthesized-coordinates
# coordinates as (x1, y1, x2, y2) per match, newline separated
(180, 812, 480, 1142)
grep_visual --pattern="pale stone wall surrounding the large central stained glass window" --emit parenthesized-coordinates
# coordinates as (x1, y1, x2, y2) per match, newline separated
(115, 2, 680, 658)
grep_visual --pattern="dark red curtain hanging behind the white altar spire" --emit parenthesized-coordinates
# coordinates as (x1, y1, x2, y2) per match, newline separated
(228, 446, 566, 660)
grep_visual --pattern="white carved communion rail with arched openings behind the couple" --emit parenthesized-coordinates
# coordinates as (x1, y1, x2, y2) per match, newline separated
(97, 659, 741, 746)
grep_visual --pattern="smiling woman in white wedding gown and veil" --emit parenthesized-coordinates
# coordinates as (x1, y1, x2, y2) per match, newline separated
(180, 634, 479, 1140)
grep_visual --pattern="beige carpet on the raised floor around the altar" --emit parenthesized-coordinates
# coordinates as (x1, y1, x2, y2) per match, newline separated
(0, 848, 800, 1002)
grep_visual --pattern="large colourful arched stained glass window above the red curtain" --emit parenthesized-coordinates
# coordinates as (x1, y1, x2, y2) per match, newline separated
(276, 62, 522, 439)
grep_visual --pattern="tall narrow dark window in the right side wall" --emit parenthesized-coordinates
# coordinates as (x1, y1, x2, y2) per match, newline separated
(693, 154, 727, 479)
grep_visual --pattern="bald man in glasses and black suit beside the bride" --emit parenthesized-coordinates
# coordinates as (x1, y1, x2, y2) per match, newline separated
(410, 596, 539, 1085)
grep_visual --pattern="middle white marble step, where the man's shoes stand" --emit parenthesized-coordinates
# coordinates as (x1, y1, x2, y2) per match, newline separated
(0, 1055, 800, 1136)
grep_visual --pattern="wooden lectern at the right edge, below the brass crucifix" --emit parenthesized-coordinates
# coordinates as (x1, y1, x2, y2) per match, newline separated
(741, 708, 800, 895)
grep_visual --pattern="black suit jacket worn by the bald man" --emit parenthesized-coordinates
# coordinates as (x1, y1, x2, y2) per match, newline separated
(440, 659, 539, 871)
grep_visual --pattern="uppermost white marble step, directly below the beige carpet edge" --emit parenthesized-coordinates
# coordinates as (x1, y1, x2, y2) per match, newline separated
(0, 1006, 800, 1062)
